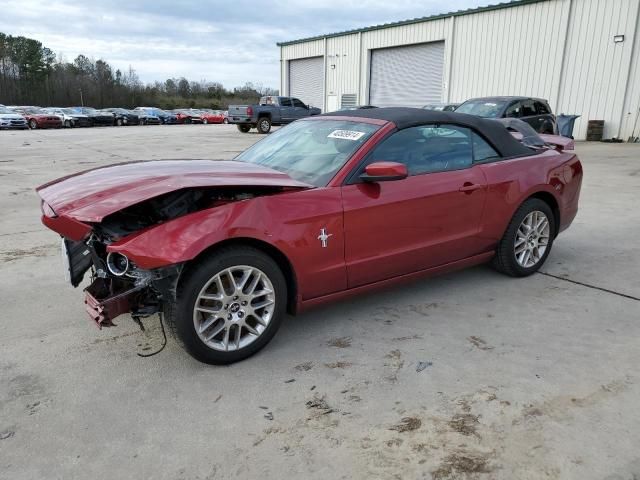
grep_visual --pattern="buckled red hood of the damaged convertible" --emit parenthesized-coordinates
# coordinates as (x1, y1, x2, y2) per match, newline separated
(36, 160, 312, 222)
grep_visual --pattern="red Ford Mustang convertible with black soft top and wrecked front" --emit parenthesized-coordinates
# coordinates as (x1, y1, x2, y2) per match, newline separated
(37, 108, 582, 363)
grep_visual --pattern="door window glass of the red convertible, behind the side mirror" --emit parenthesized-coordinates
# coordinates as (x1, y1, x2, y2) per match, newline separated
(368, 125, 473, 175)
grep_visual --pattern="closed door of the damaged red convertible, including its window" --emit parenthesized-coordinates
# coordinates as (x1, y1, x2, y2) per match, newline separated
(342, 125, 491, 288)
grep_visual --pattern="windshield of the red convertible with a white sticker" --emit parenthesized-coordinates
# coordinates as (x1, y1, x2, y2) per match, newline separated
(235, 120, 380, 187)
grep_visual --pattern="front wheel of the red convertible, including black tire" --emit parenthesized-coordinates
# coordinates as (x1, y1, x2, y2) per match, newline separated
(165, 246, 287, 365)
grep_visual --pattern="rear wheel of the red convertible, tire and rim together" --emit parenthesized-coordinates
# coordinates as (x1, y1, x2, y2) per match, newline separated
(493, 198, 556, 277)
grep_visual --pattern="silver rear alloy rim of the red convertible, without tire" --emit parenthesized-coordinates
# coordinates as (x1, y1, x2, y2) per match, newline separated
(513, 210, 550, 268)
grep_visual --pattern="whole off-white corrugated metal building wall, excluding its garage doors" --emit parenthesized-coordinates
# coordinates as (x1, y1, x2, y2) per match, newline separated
(281, 0, 640, 139)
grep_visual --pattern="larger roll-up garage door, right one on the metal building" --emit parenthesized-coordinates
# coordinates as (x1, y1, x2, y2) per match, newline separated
(369, 42, 444, 107)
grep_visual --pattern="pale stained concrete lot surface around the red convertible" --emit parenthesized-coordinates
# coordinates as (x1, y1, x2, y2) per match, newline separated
(0, 125, 640, 480)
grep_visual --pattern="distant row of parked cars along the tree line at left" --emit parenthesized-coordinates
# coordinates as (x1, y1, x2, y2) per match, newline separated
(0, 105, 228, 130)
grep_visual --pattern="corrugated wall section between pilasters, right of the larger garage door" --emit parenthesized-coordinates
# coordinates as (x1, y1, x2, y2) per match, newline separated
(449, 1, 569, 103)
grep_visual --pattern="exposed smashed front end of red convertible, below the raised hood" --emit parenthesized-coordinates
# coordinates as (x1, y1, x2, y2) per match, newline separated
(50, 187, 292, 328)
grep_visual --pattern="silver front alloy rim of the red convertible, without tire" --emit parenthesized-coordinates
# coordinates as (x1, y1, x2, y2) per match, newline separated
(193, 265, 276, 352)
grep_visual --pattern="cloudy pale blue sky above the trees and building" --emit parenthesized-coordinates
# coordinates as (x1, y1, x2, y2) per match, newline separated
(0, 0, 484, 88)
